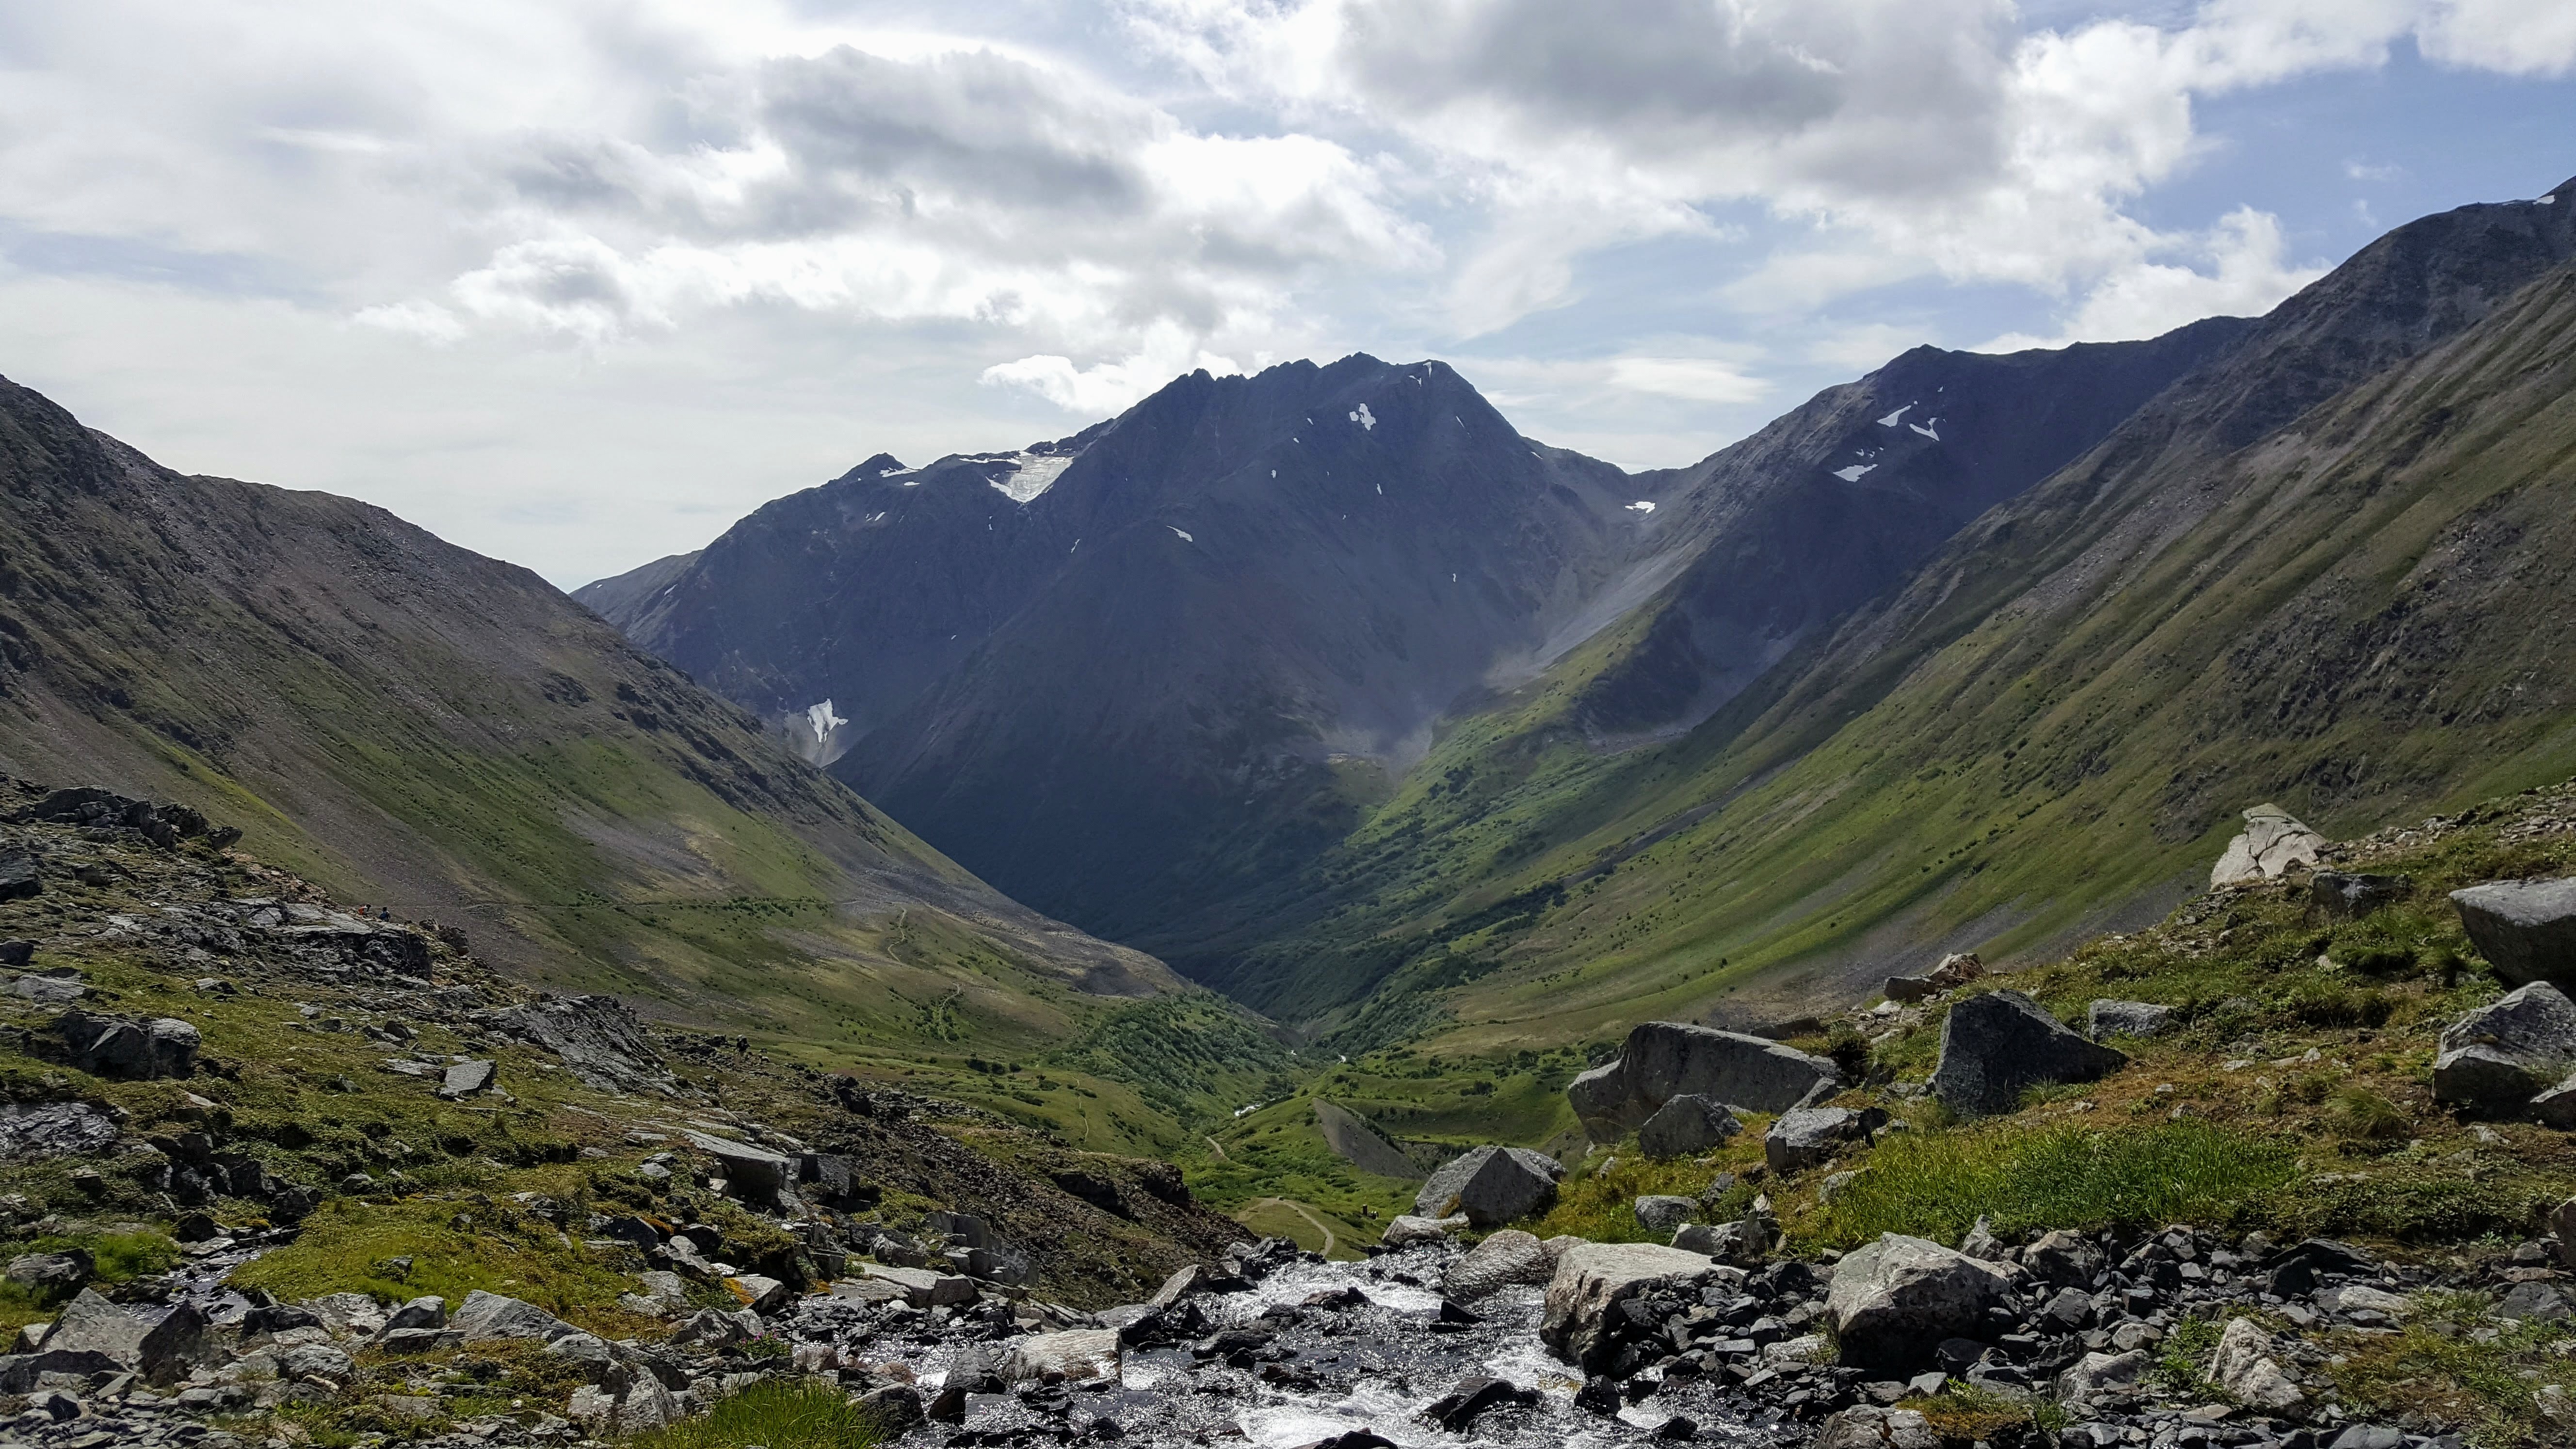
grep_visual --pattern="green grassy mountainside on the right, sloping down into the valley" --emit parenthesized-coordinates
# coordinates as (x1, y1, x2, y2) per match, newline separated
(1226, 175, 2576, 1039)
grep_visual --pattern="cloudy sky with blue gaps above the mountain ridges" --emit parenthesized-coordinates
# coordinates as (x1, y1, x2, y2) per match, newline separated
(0, 0, 2576, 588)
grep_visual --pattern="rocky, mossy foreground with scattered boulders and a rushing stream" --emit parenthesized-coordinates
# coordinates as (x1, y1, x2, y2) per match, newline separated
(0, 791, 2576, 1449)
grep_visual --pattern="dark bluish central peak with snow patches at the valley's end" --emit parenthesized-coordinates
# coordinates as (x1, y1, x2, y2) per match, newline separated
(585, 356, 1654, 941)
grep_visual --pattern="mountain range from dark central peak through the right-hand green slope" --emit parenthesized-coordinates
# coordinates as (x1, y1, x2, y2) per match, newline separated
(577, 169, 2576, 1052)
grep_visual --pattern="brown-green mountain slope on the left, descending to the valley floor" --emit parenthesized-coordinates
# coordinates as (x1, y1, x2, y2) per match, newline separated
(0, 373, 1272, 1145)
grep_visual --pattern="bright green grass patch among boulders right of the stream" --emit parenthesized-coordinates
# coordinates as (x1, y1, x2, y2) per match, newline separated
(1801, 1122, 2298, 1248)
